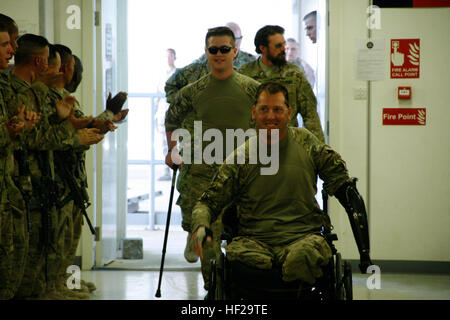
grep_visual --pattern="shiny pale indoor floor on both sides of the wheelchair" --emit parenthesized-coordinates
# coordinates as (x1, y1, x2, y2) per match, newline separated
(82, 270, 450, 300)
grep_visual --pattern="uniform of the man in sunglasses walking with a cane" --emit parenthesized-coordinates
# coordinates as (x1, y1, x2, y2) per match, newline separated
(165, 71, 259, 286)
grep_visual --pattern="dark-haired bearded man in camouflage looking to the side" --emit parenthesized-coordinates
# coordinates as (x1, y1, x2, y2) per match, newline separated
(238, 25, 325, 142)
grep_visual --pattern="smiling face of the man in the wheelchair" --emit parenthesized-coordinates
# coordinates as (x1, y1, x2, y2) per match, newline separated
(252, 91, 292, 140)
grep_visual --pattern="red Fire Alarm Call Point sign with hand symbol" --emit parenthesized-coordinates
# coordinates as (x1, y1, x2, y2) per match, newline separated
(391, 39, 420, 79)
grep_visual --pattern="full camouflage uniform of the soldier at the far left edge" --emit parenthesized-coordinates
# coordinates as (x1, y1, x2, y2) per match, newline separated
(0, 70, 28, 300)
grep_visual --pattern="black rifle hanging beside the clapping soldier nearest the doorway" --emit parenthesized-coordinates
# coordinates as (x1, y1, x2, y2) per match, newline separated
(53, 152, 96, 236)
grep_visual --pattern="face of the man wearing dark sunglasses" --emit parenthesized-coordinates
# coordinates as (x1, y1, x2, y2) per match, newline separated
(205, 36, 237, 73)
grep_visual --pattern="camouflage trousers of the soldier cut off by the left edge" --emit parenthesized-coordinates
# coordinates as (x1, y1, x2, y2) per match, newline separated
(0, 201, 28, 300)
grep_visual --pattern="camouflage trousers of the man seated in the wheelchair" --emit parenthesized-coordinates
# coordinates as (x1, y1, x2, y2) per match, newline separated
(226, 234, 332, 284)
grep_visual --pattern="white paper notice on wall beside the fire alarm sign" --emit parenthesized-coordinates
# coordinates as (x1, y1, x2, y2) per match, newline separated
(355, 39, 386, 81)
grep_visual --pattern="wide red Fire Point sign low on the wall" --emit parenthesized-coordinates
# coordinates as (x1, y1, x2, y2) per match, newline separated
(383, 108, 427, 126)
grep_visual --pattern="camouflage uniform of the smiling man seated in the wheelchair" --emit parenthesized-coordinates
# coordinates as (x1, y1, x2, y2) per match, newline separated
(192, 127, 350, 283)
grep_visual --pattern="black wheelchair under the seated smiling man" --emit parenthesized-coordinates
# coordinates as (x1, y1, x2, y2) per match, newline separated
(206, 199, 353, 301)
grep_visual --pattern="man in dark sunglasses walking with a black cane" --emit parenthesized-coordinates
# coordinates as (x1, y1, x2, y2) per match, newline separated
(165, 27, 259, 288)
